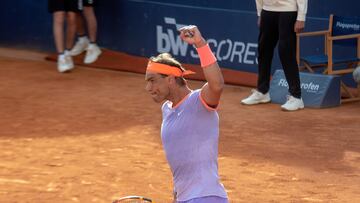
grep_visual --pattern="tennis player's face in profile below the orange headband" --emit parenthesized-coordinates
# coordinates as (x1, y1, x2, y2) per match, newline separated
(145, 72, 170, 103)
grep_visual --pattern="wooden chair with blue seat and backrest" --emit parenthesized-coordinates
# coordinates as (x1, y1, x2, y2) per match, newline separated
(296, 15, 360, 103)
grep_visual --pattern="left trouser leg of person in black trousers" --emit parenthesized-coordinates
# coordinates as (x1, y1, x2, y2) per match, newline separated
(257, 10, 279, 94)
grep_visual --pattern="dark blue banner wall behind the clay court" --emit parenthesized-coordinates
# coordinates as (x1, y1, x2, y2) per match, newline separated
(0, 0, 360, 85)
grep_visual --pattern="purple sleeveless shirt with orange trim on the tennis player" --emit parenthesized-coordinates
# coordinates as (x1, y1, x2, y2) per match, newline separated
(161, 89, 227, 201)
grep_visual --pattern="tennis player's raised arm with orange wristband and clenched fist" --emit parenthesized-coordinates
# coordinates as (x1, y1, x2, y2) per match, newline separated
(180, 25, 224, 107)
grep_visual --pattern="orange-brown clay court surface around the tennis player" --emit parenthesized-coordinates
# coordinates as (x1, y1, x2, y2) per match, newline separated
(0, 49, 360, 203)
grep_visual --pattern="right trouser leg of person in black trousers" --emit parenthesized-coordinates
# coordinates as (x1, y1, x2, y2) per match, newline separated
(279, 12, 301, 99)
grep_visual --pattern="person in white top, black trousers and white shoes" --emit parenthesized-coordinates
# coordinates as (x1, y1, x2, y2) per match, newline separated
(241, 0, 308, 111)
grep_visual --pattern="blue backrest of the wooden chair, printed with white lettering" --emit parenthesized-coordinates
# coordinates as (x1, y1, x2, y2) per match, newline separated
(329, 15, 360, 46)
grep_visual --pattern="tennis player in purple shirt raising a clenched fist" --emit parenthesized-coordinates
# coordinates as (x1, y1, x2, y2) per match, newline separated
(145, 25, 228, 203)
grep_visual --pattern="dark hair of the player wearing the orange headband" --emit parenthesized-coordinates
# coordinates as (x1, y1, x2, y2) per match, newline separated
(150, 53, 186, 86)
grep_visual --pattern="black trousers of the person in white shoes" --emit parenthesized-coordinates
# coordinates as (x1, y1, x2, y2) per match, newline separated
(257, 10, 301, 98)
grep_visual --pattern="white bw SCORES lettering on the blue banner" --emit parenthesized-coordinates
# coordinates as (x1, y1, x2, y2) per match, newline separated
(156, 17, 258, 65)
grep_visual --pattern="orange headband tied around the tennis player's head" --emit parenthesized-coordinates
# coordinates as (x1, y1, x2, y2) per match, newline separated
(146, 61, 195, 77)
